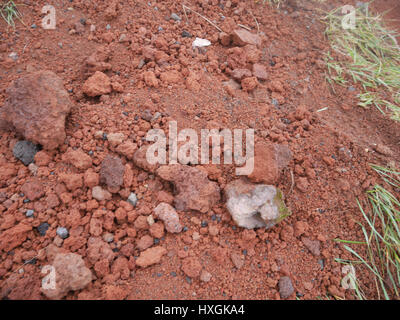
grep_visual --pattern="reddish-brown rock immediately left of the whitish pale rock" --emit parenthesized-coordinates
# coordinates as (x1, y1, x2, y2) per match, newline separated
(157, 164, 221, 213)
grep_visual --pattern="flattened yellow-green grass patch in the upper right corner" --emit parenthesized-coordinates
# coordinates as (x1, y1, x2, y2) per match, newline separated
(323, 6, 400, 121)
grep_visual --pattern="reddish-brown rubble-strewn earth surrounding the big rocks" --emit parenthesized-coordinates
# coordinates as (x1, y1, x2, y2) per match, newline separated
(0, 0, 400, 299)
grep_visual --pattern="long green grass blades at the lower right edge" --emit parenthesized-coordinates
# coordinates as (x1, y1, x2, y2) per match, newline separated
(336, 165, 400, 300)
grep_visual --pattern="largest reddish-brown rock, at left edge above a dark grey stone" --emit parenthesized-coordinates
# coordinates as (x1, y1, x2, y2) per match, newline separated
(0, 71, 72, 150)
